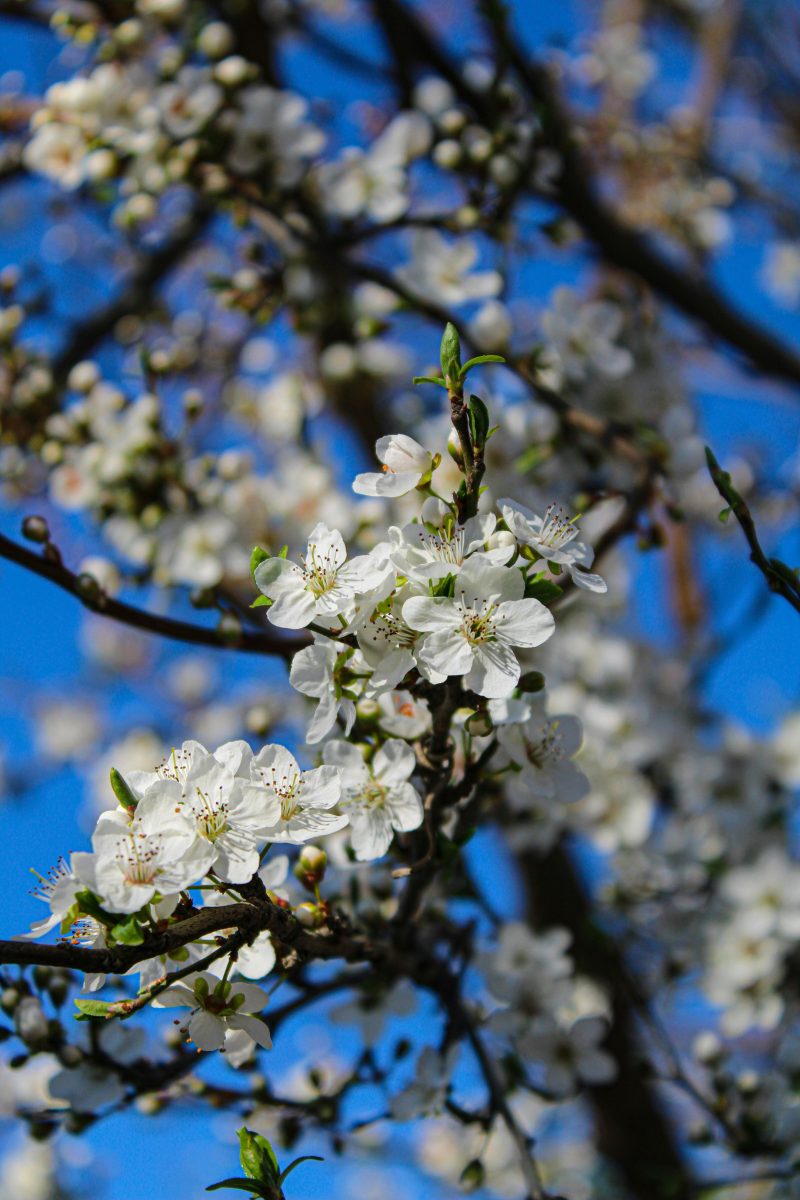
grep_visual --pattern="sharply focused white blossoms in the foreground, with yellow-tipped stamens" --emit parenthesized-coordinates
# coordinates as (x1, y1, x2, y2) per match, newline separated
(18, 376, 606, 1064)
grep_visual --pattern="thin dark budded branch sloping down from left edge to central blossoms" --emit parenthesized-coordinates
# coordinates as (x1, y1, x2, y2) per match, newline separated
(0, 534, 307, 660)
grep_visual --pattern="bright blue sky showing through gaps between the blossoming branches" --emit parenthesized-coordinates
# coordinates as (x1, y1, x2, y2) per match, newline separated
(0, 0, 800, 1200)
